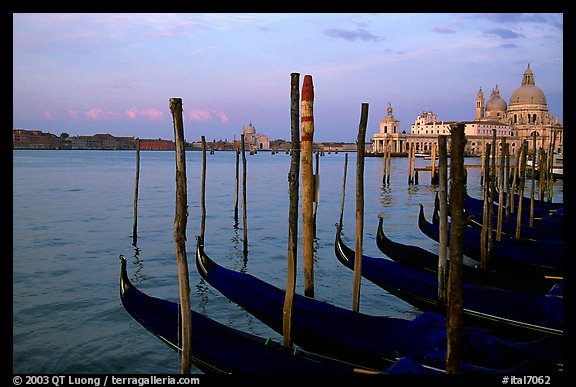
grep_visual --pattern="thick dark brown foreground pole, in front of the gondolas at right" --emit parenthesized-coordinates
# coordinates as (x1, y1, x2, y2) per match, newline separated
(446, 123, 466, 374)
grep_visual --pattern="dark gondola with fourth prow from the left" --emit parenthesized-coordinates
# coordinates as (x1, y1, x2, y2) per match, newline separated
(376, 215, 561, 293)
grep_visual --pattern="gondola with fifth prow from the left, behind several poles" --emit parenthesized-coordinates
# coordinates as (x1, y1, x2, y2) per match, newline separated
(418, 204, 564, 277)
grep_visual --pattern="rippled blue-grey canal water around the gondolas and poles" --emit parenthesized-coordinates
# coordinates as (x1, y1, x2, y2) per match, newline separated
(12, 150, 563, 374)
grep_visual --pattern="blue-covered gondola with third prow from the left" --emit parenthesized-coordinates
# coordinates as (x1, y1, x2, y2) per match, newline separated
(335, 226, 564, 340)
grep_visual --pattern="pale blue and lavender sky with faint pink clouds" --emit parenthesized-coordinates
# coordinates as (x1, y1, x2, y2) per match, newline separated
(12, 13, 564, 142)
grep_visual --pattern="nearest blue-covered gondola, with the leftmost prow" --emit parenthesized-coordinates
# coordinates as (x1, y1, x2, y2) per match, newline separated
(120, 256, 400, 375)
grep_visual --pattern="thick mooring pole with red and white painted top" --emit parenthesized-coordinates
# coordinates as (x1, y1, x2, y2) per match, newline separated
(301, 75, 314, 297)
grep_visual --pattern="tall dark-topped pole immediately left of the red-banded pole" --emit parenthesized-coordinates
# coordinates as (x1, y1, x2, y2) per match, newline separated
(282, 73, 300, 346)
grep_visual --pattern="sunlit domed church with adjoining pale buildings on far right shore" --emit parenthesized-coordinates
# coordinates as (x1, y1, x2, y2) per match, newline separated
(372, 65, 564, 156)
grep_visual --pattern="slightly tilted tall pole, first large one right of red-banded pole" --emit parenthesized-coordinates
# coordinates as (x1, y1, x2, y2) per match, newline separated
(352, 103, 368, 312)
